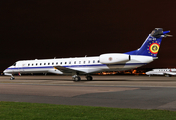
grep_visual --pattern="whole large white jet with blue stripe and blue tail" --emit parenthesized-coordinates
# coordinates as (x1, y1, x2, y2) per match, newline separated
(4, 28, 170, 81)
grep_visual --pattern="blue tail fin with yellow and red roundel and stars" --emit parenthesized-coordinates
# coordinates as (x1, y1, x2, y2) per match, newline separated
(125, 28, 170, 57)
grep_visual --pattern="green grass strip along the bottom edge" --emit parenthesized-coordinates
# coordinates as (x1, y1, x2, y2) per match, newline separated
(0, 102, 176, 120)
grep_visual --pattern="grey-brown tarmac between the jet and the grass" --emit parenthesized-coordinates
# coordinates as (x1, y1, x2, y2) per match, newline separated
(0, 75, 176, 111)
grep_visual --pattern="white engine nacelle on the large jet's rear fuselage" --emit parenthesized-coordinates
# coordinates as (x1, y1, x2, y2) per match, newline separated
(100, 53, 131, 64)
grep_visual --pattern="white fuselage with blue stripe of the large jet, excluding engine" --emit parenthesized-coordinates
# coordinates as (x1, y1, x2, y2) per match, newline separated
(4, 55, 153, 75)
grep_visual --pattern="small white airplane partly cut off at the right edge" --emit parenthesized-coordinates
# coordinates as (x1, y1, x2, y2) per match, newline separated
(145, 68, 176, 77)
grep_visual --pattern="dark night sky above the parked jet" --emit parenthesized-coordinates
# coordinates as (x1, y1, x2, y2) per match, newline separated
(0, 0, 176, 71)
